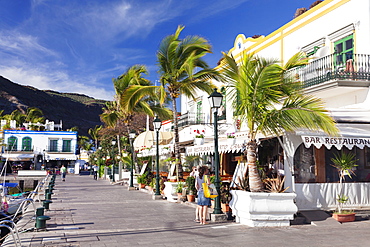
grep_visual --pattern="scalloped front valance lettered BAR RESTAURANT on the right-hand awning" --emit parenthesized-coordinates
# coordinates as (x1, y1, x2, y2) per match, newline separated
(301, 136, 370, 150)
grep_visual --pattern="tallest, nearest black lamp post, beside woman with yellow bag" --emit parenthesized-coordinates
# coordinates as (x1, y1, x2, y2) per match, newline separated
(208, 88, 223, 214)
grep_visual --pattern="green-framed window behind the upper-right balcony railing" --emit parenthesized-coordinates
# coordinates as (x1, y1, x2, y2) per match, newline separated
(334, 34, 354, 67)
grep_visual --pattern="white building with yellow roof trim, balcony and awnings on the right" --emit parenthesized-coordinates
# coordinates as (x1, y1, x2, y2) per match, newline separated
(179, 0, 370, 210)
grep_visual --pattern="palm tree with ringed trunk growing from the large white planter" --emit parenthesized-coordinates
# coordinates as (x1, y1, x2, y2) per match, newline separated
(221, 53, 338, 192)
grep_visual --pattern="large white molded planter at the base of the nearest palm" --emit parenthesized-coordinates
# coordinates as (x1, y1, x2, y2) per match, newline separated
(230, 190, 298, 227)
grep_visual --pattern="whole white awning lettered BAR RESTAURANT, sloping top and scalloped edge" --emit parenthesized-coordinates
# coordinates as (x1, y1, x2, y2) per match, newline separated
(296, 124, 370, 150)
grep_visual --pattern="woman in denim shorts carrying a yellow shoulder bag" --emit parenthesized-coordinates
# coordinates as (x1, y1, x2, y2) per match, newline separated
(195, 166, 211, 225)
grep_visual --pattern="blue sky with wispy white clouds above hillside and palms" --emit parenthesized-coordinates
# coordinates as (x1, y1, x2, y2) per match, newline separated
(0, 0, 315, 100)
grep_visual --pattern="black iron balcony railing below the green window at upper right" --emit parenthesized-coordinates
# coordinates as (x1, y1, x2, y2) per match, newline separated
(290, 53, 370, 88)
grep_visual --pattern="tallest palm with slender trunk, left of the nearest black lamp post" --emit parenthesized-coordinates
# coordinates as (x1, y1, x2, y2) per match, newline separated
(157, 26, 218, 178)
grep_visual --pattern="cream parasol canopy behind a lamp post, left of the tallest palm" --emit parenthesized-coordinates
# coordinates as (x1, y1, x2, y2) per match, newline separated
(134, 131, 173, 150)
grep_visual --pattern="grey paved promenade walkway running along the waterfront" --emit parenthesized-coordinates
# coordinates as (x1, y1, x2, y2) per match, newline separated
(4, 175, 370, 247)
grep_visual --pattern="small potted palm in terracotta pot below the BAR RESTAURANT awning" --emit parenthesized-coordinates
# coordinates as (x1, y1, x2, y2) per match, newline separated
(331, 150, 357, 222)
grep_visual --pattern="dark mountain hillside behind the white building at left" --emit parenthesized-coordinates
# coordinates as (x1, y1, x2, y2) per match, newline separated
(0, 76, 105, 135)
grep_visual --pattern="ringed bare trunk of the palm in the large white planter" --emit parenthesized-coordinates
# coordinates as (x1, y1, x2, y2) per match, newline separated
(246, 140, 264, 192)
